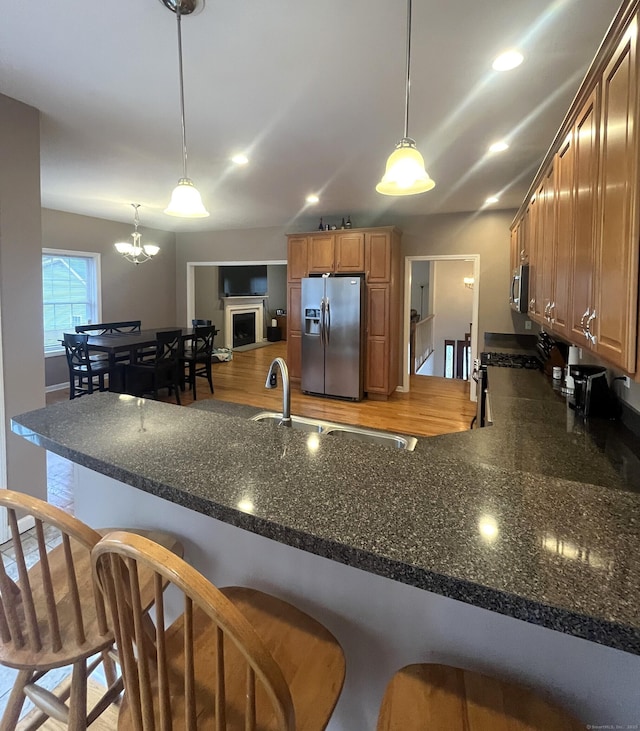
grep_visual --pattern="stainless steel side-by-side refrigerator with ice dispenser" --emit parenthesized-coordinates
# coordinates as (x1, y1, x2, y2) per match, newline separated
(301, 274, 364, 401)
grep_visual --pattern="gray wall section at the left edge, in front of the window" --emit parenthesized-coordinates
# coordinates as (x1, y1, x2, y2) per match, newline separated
(0, 95, 47, 500)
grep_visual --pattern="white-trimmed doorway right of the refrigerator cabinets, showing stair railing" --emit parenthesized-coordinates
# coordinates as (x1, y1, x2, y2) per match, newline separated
(401, 254, 480, 401)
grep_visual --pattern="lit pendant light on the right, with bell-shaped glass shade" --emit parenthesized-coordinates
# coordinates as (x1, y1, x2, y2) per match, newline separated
(376, 0, 435, 195)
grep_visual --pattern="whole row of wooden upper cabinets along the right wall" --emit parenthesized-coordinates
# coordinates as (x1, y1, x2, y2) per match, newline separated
(512, 0, 640, 379)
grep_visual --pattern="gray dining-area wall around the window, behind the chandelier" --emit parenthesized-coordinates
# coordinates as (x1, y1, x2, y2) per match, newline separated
(43, 207, 176, 386)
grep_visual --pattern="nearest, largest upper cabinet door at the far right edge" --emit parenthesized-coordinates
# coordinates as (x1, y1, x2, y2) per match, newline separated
(588, 17, 639, 373)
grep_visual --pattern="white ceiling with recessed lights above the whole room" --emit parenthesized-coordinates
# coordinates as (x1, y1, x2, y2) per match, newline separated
(0, 0, 620, 231)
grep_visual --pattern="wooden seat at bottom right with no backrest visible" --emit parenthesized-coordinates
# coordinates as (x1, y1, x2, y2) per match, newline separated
(377, 664, 586, 731)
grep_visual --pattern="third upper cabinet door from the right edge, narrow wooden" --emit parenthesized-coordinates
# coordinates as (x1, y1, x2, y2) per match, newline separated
(549, 133, 575, 337)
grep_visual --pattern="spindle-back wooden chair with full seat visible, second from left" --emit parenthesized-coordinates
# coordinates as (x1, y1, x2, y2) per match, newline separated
(93, 533, 345, 731)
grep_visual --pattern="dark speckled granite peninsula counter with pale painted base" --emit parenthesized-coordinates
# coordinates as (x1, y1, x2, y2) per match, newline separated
(12, 384, 640, 731)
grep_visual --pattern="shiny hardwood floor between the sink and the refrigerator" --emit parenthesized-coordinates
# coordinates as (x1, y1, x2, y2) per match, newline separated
(47, 341, 476, 436)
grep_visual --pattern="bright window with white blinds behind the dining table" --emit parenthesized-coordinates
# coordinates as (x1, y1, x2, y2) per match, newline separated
(42, 249, 101, 354)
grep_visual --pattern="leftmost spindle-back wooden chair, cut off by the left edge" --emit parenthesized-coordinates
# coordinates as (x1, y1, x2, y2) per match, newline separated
(0, 490, 183, 731)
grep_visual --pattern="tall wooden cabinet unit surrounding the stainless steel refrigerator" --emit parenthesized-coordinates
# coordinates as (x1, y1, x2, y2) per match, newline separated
(287, 227, 403, 400)
